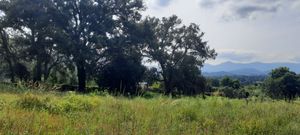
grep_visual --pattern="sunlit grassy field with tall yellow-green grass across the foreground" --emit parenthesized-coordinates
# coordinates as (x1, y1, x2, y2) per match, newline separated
(0, 86, 300, 135)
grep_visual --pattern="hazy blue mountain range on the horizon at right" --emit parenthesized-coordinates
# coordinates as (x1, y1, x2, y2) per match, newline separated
(202, 62, 300, 76)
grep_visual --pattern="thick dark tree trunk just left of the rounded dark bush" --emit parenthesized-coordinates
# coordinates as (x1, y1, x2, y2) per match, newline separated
(77, 61, 86, 92)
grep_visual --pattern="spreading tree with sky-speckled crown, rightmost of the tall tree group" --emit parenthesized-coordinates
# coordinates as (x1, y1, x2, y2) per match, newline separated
(145, 16, 216, 94)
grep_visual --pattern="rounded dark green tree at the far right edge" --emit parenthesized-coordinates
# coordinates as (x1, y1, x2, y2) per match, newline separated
(265, 67, 300, 101)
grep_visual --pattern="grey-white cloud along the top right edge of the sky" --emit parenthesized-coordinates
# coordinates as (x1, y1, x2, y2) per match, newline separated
(198, 0, 300, 21)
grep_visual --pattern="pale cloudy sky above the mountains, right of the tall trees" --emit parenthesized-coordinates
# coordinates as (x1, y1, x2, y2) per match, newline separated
(144, 0, 300, 64)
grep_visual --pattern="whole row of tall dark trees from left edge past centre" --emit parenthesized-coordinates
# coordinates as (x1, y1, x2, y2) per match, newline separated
(0, 0, 216, 95)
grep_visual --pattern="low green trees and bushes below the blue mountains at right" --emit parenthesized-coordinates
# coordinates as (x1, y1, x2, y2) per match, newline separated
(208, 67, 300, 101)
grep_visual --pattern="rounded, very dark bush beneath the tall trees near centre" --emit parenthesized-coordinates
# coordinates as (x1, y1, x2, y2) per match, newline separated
(97, 56, 145, 96)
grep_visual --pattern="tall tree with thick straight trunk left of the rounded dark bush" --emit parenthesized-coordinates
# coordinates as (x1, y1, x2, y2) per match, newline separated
(52, 0, 142, 92)
